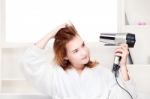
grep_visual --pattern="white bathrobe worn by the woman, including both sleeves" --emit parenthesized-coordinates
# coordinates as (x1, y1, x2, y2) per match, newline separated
(21, 45, 136, 99)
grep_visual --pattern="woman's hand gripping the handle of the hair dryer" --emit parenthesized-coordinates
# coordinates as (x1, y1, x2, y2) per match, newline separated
(115, 43, 129, 67)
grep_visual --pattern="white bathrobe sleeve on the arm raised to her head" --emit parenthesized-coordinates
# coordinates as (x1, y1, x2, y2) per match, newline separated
(19, 45, 56, 96)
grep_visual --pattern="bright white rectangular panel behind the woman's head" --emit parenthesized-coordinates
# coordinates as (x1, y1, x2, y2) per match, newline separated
(5, 0, 117, 42)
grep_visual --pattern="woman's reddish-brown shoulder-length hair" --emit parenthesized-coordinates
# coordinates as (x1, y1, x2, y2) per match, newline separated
(53, 25, 98, 70)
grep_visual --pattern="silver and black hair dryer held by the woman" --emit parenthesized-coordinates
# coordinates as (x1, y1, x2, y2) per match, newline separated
(100, 33, 136, 76)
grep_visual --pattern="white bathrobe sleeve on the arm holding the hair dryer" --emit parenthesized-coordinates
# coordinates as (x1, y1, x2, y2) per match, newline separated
(107, 67, 137, 99)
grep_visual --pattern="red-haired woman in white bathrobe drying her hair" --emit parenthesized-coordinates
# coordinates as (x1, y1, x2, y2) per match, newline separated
(21, 23, 136, 99)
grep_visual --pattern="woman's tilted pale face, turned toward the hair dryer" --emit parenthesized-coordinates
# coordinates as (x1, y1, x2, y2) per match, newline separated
(65, 36, 90, 68)
